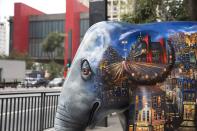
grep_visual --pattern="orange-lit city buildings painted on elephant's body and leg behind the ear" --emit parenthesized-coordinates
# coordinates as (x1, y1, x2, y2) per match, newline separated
(129, 29, 197, 131)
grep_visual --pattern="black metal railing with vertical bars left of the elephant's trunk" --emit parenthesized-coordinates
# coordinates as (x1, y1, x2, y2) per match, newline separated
(0, 90, 60, 131)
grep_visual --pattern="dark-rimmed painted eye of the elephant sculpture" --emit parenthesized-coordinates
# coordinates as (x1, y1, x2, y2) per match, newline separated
(81, 59, 92, 80)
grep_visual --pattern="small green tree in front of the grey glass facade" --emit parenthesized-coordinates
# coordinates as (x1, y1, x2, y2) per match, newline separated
(42, 32, 64, 59)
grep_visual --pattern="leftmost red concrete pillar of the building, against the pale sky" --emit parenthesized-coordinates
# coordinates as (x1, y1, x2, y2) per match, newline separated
(13, 3, 44, 53)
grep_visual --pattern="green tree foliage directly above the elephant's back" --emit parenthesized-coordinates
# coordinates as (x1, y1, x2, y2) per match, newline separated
(122, 0, 194, 23)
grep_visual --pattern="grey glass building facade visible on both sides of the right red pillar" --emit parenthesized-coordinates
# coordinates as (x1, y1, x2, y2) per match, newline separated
(29, 14, 89, 59)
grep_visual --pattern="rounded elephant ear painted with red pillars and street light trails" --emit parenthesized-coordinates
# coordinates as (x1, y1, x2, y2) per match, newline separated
(126, 41, 175, 85)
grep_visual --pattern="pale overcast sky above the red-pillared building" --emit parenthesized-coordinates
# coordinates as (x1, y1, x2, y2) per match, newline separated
(0, 0, 66, 21)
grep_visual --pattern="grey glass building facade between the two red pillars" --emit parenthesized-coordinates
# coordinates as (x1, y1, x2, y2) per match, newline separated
(29, 19, 65, 58)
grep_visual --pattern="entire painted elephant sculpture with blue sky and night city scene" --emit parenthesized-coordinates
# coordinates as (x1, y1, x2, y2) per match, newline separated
(55, 22, 197, 131)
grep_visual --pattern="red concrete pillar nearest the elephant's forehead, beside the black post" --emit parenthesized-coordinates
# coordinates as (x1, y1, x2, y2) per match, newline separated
(64, 0, 89, 65)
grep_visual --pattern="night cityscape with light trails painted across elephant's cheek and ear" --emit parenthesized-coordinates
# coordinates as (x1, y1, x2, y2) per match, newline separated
(97, 32, 174, 105)
